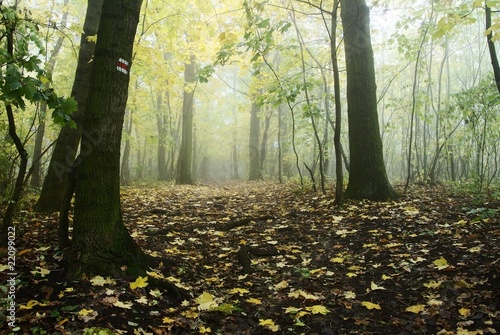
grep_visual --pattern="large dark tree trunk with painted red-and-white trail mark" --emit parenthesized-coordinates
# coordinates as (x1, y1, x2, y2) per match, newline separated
(68, 0, 147, 279)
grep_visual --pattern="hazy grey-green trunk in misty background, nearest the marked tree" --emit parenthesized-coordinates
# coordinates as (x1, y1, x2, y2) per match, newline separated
(176, 56, 196, 184)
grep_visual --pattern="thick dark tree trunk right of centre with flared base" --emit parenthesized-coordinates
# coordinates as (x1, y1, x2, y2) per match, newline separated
(341, 0, 396, 200)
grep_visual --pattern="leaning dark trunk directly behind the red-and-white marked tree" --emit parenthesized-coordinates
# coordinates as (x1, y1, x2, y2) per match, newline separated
(35, 0, 104, 212)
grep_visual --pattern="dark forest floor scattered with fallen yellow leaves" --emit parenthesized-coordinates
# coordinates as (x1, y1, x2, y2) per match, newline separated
(0, 182, 500, 335)
